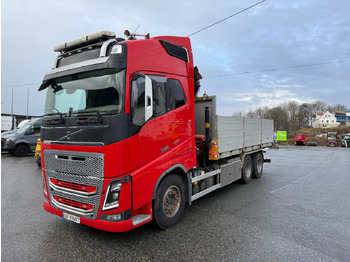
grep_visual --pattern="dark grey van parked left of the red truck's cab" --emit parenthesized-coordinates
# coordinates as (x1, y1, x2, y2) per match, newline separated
(1, 118, 42, 157)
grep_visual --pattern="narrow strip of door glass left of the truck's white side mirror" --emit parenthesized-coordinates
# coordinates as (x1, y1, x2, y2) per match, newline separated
(131, 76, 145, 126)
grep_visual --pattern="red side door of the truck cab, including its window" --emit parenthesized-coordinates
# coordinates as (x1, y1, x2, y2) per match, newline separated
(129, 74, 172, 168)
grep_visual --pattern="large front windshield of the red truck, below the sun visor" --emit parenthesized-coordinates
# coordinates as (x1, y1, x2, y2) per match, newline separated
(45, 69, 125, 115)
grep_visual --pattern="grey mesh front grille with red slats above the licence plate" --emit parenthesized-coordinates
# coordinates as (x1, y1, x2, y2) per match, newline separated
(44, 150, 104, 219)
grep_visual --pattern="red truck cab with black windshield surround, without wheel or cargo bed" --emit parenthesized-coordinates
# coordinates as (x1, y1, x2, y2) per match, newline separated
(39, 31, 196, 231)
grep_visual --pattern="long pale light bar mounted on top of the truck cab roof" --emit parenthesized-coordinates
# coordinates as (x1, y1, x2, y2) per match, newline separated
(53, 31, 116, 53)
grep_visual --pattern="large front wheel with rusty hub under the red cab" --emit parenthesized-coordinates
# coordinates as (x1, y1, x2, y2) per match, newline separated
(153, 175, 186, 229)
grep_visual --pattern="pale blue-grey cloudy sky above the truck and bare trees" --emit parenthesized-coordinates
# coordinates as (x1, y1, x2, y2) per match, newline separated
(1, 0, 350, 115)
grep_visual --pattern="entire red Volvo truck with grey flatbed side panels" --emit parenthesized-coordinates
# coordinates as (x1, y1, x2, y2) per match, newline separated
(39, 31, 273, 232)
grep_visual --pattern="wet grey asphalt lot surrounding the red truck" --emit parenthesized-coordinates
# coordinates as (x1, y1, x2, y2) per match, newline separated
(1, 146, 350, 262)
